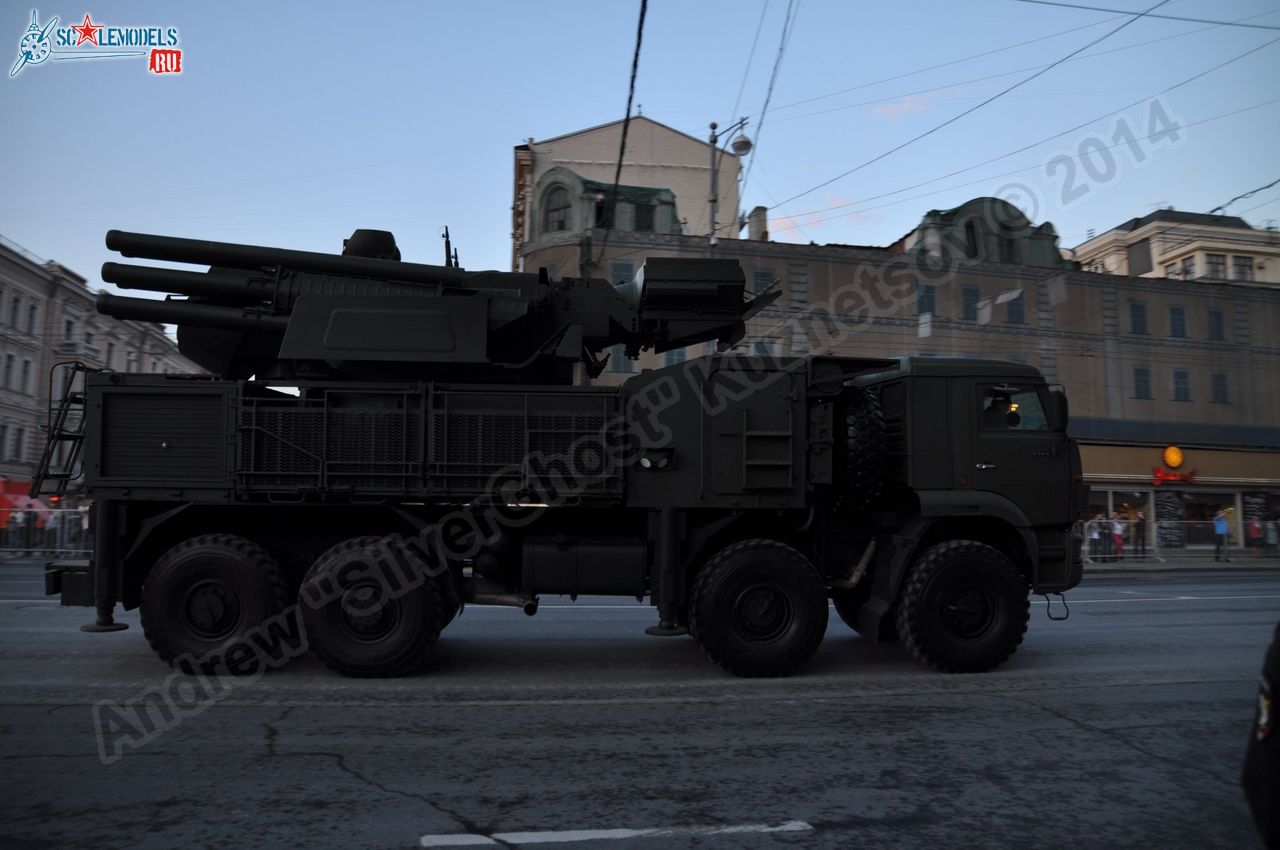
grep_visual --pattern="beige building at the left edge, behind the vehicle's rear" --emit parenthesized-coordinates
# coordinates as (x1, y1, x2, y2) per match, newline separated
(0, 237, 202, 499)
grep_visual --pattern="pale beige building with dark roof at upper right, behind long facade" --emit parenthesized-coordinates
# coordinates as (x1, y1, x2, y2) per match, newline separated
(1073, 210, 1280, 283)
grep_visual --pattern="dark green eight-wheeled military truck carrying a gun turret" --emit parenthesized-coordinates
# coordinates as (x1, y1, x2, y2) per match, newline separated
(33, 230, 1087, 676)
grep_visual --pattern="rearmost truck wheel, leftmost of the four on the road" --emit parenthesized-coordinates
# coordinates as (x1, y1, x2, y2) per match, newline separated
(141, 534, 285, 673)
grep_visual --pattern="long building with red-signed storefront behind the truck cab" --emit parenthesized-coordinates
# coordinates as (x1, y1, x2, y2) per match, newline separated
(517, 133, 1280, 557)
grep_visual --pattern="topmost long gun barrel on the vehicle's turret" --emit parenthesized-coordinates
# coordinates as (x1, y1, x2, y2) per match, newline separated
(106, 230, 467, 285)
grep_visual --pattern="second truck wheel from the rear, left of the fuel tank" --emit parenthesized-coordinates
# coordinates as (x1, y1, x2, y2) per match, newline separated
(298, 536, 444, 677)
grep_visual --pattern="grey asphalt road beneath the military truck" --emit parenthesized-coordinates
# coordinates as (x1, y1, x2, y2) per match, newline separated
(0, 565, 1280, 850)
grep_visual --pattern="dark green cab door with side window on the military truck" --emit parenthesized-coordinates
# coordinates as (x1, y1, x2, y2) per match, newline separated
(952, 380, 1075, 526)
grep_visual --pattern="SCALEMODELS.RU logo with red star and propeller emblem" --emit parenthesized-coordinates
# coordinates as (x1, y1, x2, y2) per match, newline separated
(9, 9, 182, 77)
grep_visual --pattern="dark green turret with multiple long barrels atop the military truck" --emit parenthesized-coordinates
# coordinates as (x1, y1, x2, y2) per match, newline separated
(97, 230, 778, 383)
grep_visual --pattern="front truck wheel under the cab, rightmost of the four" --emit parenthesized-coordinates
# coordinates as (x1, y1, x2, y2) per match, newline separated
(897, 540, 1030, 673)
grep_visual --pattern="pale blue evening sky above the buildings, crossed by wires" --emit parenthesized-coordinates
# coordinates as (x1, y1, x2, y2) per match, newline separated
(0, 0, 1280, 281)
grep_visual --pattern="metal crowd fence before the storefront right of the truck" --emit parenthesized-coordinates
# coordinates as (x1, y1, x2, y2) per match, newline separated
(1083, 516, 1280, 563)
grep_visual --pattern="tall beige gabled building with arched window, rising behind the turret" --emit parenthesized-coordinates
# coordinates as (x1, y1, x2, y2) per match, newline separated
(512, 115, 741, 277)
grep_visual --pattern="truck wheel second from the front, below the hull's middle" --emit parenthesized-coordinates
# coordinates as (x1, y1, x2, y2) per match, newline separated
(690, 540, 827, 676)
